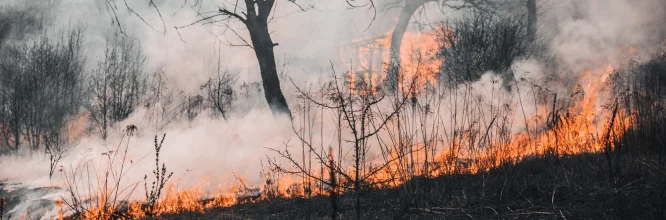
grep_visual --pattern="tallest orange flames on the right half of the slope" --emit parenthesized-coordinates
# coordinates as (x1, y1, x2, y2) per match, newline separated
(358, 65, 634, 184)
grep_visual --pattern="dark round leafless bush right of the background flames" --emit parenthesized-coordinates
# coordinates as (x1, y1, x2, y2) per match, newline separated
(440, 12, 527, 85)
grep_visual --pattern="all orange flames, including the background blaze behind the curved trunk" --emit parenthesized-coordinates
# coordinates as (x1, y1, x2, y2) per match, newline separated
(72, 35, 648, 219)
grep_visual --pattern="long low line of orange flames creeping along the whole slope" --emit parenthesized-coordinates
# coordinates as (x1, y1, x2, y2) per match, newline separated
(76, 60, 633, 219)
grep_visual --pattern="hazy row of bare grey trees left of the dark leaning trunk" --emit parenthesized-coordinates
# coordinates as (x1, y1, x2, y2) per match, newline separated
(0, 28, 241, 158)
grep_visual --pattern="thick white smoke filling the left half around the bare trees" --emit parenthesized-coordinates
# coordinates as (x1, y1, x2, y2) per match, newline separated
(0, 0, 378, 219)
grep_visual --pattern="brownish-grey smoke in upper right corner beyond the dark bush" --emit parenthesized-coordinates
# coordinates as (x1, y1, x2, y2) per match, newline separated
(514, 0, 666, 101)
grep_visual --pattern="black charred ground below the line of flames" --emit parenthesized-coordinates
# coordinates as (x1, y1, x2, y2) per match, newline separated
(154, 154, 666, 219)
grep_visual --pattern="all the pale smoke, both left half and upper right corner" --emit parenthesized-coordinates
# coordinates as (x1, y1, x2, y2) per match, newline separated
(0, 0, 666, 218)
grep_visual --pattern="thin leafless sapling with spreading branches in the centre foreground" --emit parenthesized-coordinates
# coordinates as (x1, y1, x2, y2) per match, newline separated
(269, 62, 413, 219)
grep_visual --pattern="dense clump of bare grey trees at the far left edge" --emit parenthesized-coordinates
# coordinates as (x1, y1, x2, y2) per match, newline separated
(0, 30, 84, 153)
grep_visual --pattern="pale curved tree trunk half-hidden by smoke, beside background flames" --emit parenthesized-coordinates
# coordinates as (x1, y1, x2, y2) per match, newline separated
(386, 0, 435, 91)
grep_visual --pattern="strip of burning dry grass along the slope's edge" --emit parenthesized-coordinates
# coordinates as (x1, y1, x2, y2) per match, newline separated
(67, 61, 636, 219)
